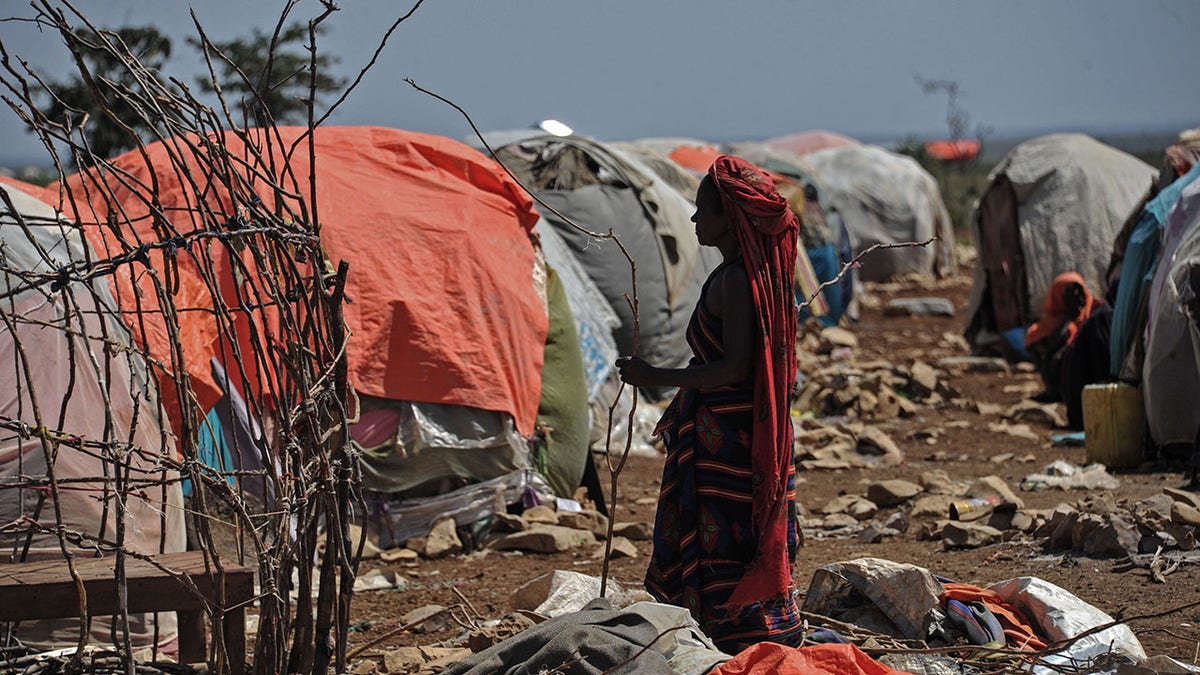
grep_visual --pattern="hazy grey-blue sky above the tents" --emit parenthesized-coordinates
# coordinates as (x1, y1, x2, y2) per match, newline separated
(0, 0, 1200, 165)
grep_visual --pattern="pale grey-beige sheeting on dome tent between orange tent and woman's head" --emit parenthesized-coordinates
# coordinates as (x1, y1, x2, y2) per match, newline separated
(488, 131, 719, 395)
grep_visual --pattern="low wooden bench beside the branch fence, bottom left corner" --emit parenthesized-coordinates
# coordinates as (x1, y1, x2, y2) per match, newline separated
(0, 551, 254, 675)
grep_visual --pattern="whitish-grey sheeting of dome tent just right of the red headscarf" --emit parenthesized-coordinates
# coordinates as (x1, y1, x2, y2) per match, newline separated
(804, 145, 955, 281)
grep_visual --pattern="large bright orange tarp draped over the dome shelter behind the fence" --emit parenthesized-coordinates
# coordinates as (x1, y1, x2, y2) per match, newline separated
(57, 126, 547, 434)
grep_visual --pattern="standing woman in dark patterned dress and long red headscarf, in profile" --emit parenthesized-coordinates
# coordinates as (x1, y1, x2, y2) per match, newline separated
(617, 156, 802, 653)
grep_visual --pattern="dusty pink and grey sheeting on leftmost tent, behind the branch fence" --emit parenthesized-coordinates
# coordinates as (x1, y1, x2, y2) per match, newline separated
(0, 181, 185, 646)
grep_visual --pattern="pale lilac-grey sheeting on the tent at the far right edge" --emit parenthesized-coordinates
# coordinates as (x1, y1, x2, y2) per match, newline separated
(1141, 180, 1200, 446)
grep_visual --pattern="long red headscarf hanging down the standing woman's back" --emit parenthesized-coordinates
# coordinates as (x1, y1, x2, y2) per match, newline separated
(708, 155, 799, 608)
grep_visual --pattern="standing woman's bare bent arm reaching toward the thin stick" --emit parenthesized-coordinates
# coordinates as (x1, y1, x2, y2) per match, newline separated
(617, 264, 756, 389)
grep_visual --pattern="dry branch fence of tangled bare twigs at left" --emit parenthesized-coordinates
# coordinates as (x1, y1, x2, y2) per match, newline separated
(0, 0, 419, 673)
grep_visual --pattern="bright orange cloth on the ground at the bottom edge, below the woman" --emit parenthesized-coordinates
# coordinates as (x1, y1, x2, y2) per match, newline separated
(709, 643, 904, 675)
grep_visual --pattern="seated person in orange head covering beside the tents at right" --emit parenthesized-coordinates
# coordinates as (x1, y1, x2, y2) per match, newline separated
(1025, 271, 1112, 430)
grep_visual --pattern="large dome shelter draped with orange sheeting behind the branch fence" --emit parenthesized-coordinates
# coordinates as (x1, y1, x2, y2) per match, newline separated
(63, 126, 548, 491)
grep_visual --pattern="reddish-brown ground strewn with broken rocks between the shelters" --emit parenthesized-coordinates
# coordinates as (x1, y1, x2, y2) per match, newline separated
(336, 260, 1200, 673)
